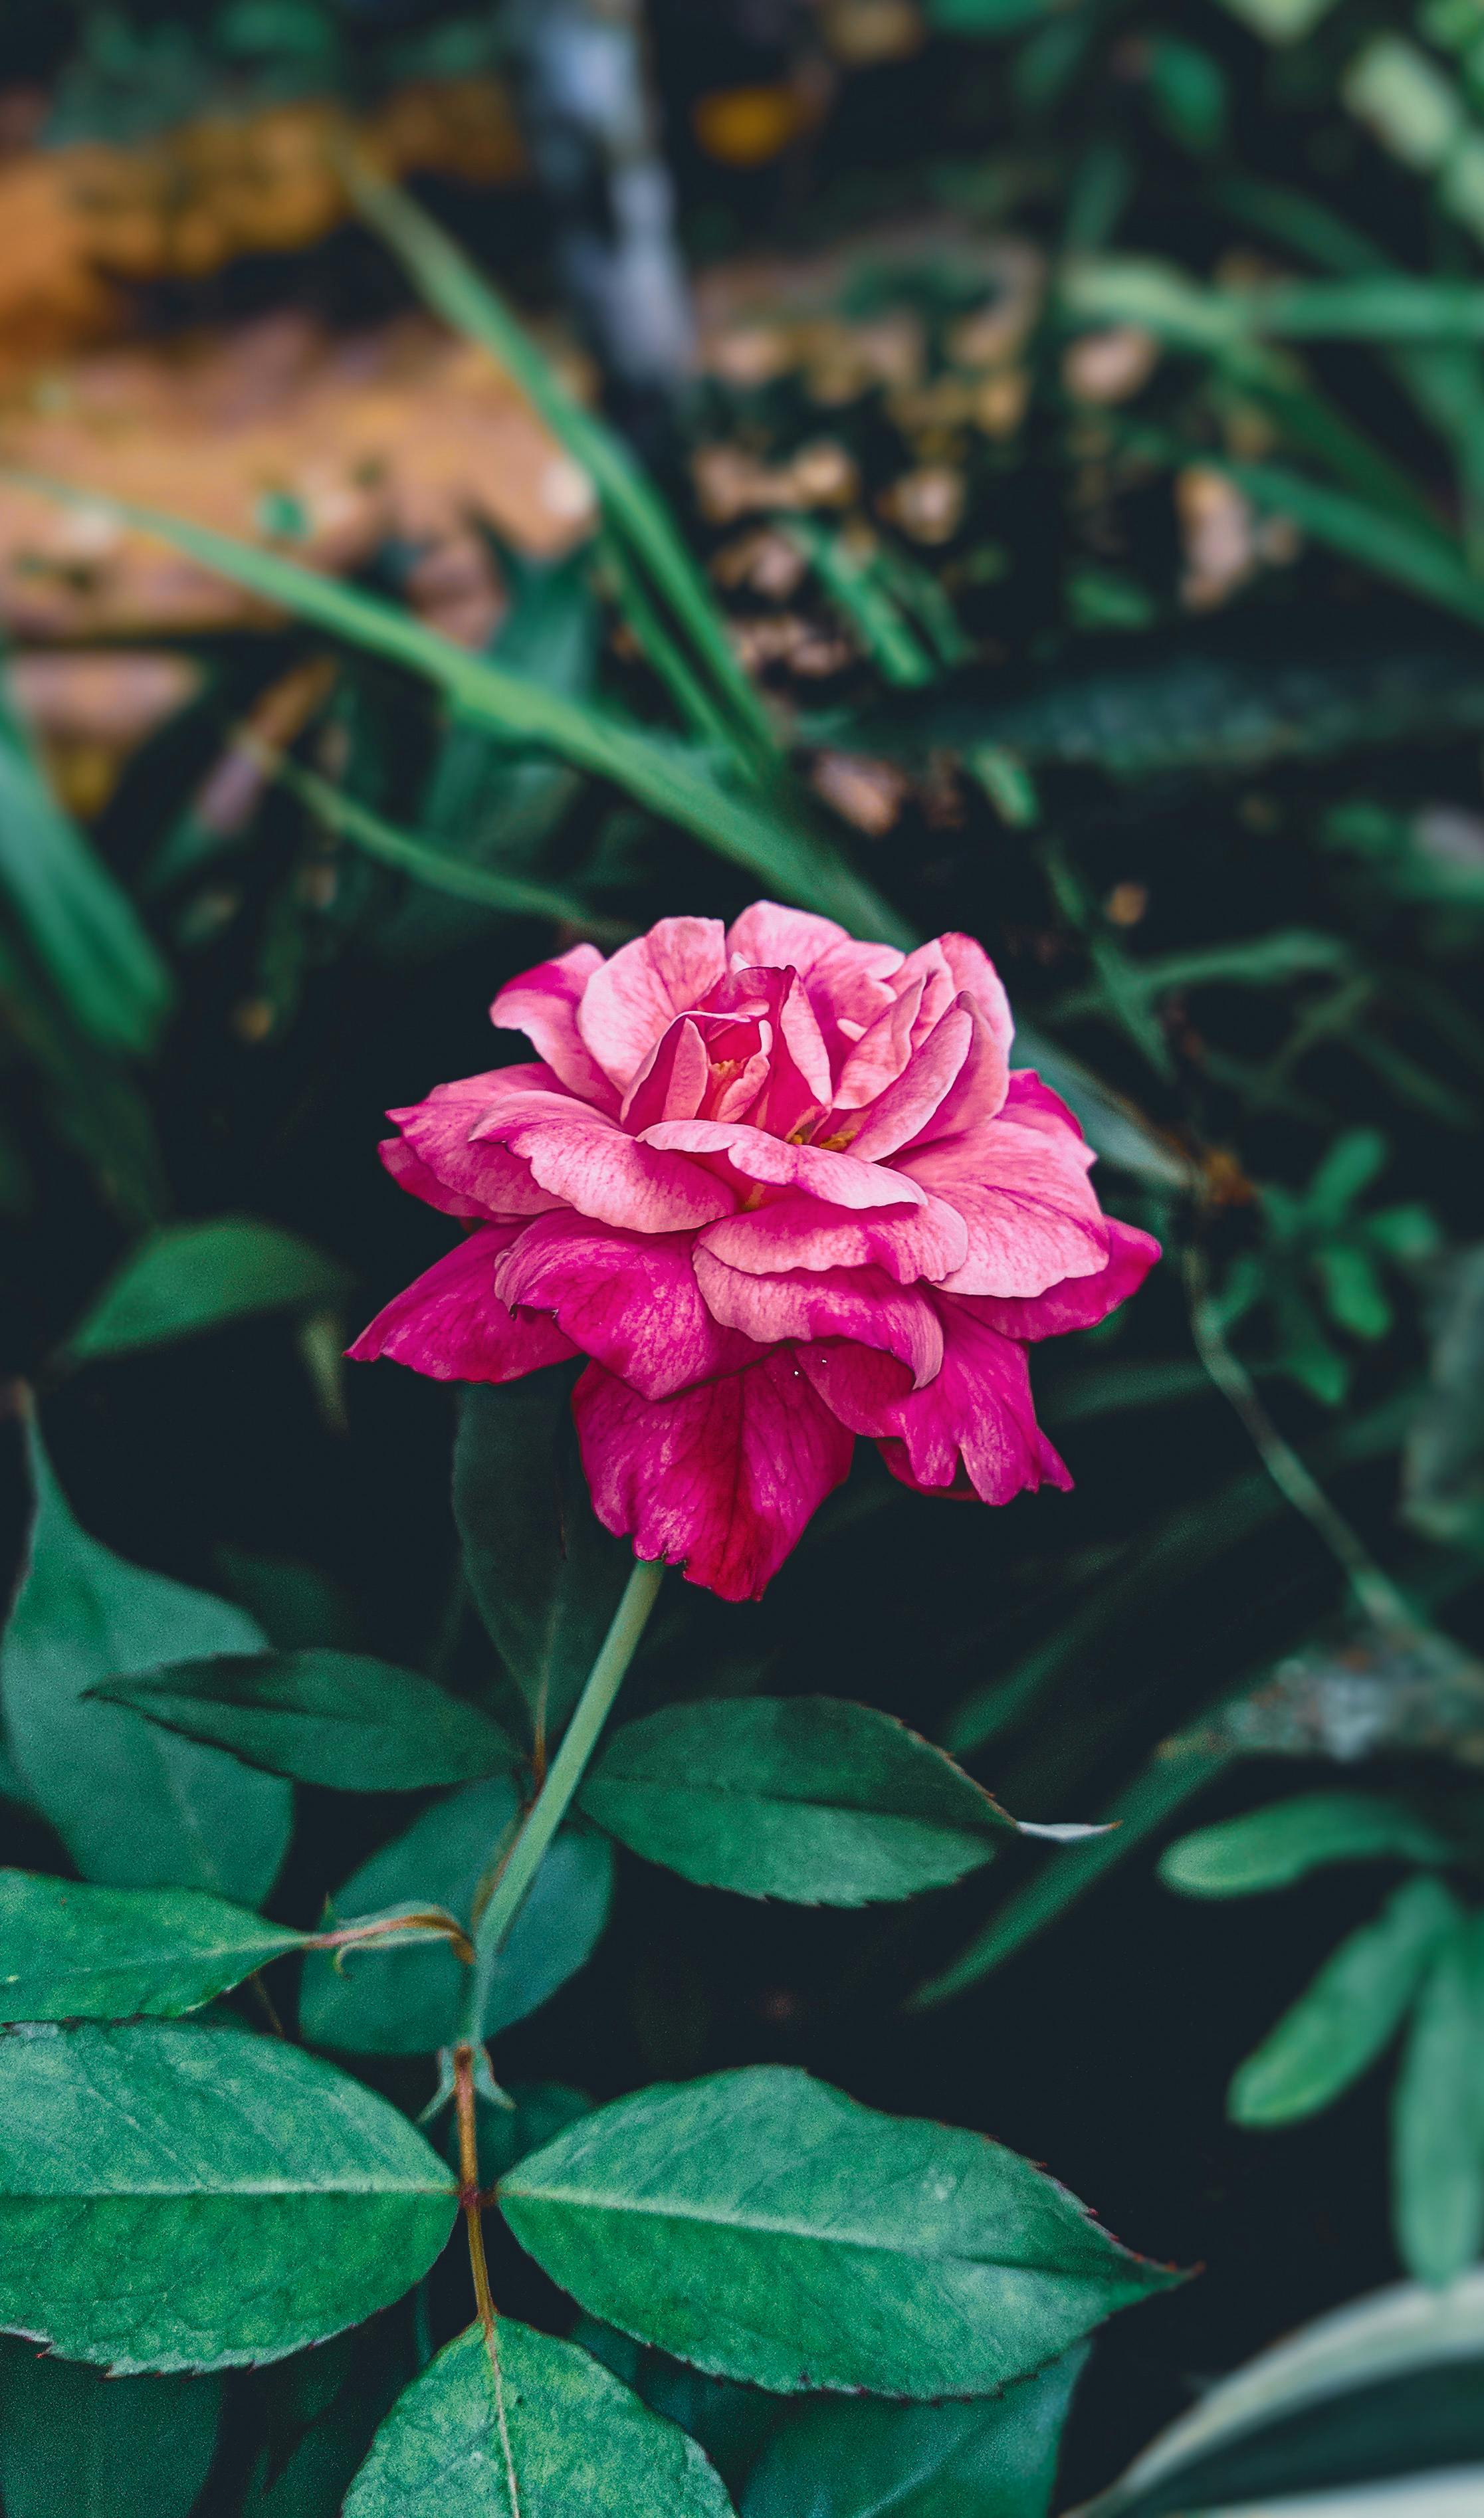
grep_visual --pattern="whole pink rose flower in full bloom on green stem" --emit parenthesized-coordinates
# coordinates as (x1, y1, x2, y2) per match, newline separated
(350, 901, 1159, 1599)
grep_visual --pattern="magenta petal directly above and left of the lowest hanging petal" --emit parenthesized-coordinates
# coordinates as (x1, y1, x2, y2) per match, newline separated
(494, 1211, 758, 1400)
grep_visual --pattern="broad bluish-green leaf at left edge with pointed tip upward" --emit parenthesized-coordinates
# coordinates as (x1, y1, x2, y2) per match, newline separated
(0, 1425, 292, 1906)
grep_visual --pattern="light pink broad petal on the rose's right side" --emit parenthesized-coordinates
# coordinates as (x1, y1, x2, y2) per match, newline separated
(899, 1118, 1109, 1295)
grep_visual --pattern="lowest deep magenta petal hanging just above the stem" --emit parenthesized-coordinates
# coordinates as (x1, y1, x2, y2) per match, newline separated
(572, 1347, 854, 1599)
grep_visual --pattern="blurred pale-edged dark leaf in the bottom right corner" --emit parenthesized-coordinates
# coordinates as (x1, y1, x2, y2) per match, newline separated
(1081, 2273, 1484, 2518)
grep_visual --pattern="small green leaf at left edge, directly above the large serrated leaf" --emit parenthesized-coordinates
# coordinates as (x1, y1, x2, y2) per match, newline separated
(0, 1871, 305, 2022)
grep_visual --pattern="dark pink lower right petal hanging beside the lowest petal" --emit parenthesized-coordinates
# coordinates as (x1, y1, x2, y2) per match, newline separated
(856, 1302, 1071, 1503)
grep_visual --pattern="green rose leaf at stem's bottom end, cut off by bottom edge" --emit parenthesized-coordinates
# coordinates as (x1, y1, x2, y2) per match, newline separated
(345, 2317, 730, 2518)
